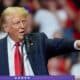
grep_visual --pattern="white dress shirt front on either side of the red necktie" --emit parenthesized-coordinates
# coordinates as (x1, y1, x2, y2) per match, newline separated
(7, 36, 34, 76)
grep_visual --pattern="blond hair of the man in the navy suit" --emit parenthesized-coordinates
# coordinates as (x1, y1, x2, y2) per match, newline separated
(1, 7, 29, 30)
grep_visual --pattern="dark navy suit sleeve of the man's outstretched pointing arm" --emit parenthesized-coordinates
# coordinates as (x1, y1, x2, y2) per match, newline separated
(42, 34, 77, 57)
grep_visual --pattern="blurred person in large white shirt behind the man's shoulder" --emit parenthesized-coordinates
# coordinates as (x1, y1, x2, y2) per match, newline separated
(34, 0, 60, 38)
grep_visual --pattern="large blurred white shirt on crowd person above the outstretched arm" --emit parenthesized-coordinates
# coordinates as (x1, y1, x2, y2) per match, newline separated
(34, 9, 60, 38)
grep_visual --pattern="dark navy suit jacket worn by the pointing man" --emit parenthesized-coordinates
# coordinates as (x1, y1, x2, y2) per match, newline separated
(0, 33, 75, 75)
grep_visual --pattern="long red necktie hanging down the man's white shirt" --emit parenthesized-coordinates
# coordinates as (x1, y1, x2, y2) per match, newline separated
(14, 43, 24, 76)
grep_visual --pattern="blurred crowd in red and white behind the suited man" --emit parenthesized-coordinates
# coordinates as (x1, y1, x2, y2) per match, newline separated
(0, 0, 80, 79)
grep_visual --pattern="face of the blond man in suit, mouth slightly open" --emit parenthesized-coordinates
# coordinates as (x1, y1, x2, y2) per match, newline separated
(4, 14, 27, 42)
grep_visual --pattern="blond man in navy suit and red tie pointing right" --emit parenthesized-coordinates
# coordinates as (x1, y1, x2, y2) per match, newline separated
(0, 7, 80, 76)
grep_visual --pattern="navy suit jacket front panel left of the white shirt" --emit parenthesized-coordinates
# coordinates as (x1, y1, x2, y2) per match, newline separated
(0, 37, 9, 75)
